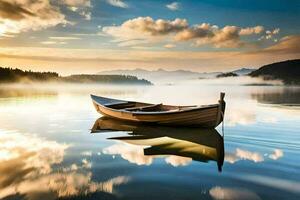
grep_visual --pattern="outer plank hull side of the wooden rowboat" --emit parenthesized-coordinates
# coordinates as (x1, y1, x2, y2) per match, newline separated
(92, 96, 225, 128)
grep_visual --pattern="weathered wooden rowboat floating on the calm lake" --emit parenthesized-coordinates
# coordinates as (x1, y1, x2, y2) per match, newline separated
(91, 93, 225, 128)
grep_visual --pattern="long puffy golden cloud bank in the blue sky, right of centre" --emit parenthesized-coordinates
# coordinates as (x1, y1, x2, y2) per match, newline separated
(102, 17, 264, 48)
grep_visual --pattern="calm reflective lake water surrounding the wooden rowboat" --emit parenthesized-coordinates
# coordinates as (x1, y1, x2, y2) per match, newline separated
(0, 84, 300, 200)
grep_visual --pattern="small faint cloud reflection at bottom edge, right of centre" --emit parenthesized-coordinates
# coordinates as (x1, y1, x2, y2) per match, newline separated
(209, 186, 261, 200)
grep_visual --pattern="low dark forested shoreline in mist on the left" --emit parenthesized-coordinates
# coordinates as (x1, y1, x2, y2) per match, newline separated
(0, 67, 152, 85)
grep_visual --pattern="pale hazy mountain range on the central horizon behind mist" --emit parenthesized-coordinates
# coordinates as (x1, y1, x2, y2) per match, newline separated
(98, 68, 221, 83)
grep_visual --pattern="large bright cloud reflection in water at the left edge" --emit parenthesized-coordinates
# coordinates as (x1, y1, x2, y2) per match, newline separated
(0, 131, 69, 189)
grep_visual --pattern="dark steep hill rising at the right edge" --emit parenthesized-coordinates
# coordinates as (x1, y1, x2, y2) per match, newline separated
(249, 59, 300, 85)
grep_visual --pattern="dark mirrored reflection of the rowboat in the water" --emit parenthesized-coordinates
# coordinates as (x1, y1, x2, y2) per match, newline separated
(92, 117, 224, 172)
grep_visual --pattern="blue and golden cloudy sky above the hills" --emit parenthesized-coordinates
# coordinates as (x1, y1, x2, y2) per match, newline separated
(0, 0, 300, 75)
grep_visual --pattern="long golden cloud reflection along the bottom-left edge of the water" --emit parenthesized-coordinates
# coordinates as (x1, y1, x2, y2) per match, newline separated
(0, 172, 130, 200)
